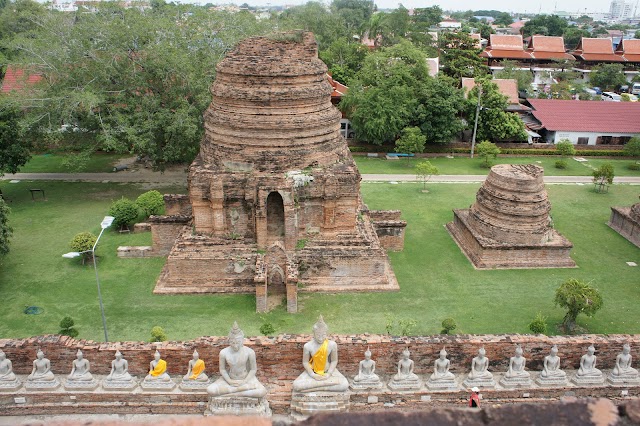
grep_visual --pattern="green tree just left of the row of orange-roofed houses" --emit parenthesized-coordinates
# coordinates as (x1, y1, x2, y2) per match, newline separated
(439, 32, 489, 81)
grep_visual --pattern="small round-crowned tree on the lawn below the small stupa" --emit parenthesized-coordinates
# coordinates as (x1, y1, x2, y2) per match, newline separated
(554, 278, 603, 333)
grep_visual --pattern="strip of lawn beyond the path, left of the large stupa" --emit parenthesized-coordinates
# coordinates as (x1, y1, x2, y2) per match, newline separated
(20, 153, 126, 173)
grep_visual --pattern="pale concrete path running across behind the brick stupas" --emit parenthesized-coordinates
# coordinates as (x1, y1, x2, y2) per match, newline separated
(0, 170, 640, 185)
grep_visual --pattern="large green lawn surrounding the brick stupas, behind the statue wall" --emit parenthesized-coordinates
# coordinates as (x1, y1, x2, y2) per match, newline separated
(0, 181, 640, 340)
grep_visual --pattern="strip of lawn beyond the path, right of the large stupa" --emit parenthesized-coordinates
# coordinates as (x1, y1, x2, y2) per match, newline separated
(354, 156, 640, 176)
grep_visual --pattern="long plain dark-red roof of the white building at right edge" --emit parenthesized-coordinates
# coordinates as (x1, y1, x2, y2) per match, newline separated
(529, 99, 640, 133)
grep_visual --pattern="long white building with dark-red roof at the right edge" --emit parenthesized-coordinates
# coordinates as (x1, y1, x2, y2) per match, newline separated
(527, 99, 640, 145)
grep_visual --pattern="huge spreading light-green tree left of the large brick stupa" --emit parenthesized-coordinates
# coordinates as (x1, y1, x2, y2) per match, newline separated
(9, 2, 269, 168)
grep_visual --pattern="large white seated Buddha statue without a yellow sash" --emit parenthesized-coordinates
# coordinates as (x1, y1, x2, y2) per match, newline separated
(207, 322, 271, 415)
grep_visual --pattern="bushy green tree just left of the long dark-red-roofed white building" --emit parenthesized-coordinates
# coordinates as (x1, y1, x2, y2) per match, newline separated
(465, 78, 527, 140)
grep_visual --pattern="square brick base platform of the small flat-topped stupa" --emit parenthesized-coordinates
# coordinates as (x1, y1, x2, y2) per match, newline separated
(446, 209, 576, 269)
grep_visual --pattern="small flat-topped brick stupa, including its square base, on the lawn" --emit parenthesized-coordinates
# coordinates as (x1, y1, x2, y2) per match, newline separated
(447, 164, 576, 269)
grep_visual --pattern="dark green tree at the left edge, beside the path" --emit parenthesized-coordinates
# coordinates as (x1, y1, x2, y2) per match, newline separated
(0, 95, 31, 176)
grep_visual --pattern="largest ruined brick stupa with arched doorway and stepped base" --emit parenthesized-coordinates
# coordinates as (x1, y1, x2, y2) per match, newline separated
(151, 32, 406, 312)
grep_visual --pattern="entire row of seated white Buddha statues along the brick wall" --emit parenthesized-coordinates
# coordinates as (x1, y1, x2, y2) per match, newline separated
(0, 316, 640, 415)
